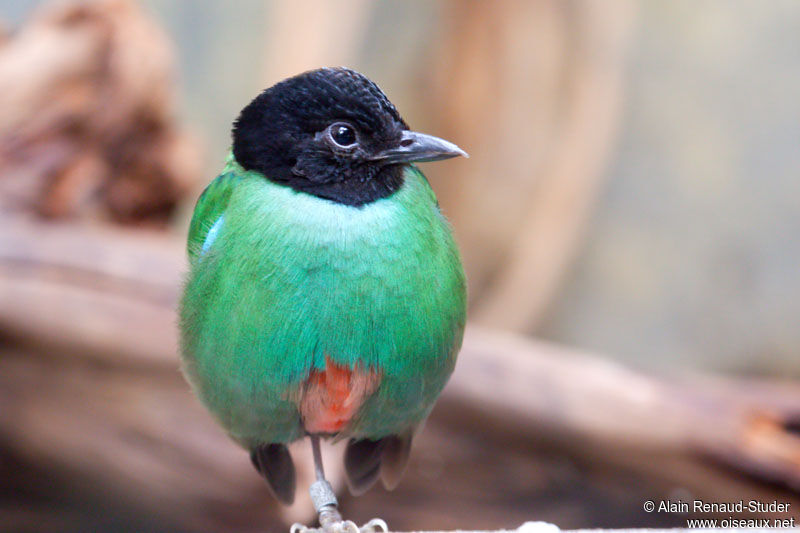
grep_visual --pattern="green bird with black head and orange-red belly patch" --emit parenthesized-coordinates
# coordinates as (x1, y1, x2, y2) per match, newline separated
(179, 67, 468, 533)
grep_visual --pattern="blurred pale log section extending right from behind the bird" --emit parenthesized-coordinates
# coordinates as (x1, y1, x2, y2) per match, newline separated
(448, 328, 800, 488)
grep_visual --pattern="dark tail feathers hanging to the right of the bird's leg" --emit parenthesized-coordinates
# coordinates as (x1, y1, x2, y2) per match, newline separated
(344, 432, 411, 496)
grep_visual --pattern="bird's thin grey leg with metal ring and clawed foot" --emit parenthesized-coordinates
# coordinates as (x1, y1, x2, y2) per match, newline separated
(290, 435, 389, 533)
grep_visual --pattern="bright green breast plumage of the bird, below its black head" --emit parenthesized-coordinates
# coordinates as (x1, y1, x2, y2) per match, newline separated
(181, 163, 465, 446)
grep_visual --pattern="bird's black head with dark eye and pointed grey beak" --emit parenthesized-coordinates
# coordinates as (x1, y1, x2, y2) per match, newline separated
(233, 68, 466, 206)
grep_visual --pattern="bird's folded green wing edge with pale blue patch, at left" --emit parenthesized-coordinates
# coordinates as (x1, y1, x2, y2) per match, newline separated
(186, 171, 241, 265)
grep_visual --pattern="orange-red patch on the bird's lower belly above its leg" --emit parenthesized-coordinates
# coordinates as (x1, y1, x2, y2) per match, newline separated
(299, 357, 381, 433)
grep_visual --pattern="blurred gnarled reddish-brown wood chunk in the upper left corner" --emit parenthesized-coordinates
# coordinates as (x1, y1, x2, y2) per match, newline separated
(0, 0, 200, 224)
